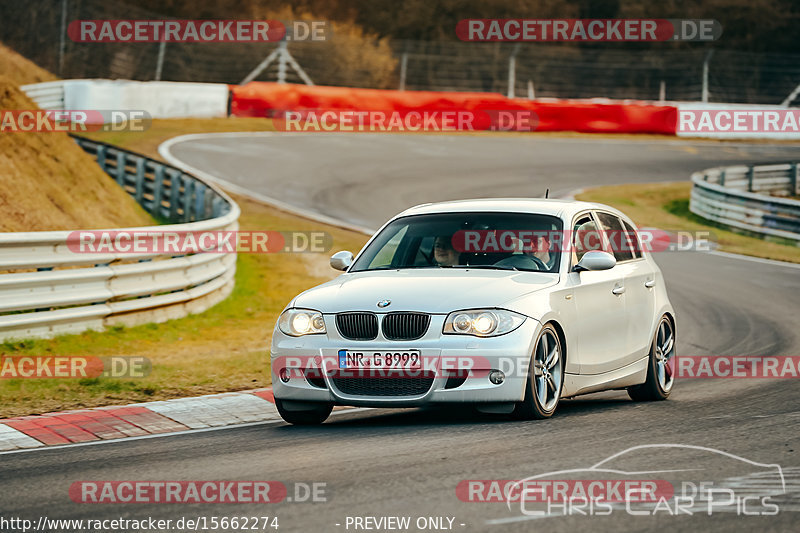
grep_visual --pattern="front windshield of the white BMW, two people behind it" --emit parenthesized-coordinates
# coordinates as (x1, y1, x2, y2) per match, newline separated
(350, 212, 562, 272)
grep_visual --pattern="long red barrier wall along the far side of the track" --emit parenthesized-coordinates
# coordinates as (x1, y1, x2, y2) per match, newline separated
(231, 82, 678, 135)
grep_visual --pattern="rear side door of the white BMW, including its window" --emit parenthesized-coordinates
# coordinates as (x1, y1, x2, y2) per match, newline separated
(596, 211, 655, 368)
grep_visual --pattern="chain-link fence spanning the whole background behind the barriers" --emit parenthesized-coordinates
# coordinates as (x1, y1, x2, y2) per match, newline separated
(0, 0, 800, 105)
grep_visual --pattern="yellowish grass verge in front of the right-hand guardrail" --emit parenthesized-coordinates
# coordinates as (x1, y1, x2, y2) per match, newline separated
(576, 181, 800, 263)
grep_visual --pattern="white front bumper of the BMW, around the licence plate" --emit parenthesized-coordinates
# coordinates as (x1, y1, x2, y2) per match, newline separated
(271, 315, 541, 407)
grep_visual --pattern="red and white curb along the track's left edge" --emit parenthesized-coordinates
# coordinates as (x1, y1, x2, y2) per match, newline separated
(0, 389, 281, 452)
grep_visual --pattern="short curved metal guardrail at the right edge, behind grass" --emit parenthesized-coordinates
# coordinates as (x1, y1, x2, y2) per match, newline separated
(689, 162, 800, 239)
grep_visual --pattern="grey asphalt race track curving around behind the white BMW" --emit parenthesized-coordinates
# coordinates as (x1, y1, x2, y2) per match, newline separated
(0, 134, 800, 532)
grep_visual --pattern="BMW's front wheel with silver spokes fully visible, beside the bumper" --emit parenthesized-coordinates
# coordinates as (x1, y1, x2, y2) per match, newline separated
(514, 324, 564, 420)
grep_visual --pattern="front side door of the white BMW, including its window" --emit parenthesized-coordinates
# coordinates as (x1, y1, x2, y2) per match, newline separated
(567, 212, 628, 374)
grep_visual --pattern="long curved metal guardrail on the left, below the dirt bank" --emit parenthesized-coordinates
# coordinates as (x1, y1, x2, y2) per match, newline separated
(0, 138, 240, 340)
